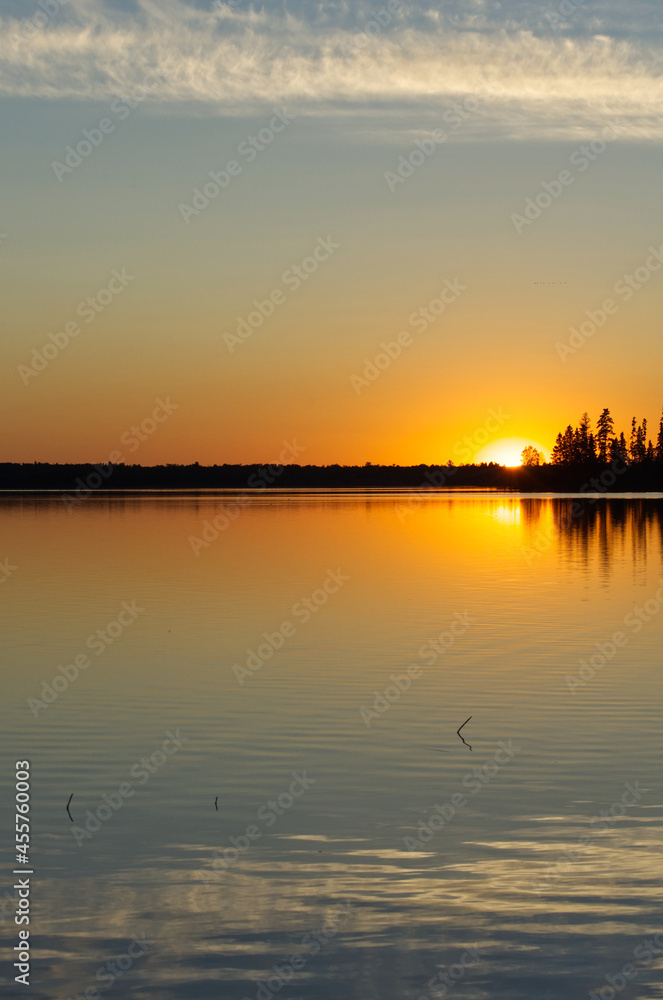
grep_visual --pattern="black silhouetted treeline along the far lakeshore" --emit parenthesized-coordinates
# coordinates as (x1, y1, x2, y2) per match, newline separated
(0, 409, 663, 494)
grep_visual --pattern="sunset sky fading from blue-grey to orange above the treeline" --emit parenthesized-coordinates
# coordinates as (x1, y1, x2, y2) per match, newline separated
(0, 0, 663, 465)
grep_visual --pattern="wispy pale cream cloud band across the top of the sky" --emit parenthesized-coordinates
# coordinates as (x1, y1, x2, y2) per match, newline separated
(0, 0, 663, 139)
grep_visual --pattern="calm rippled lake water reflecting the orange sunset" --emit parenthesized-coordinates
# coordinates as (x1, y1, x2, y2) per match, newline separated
(0, 493, 663, 1000)
